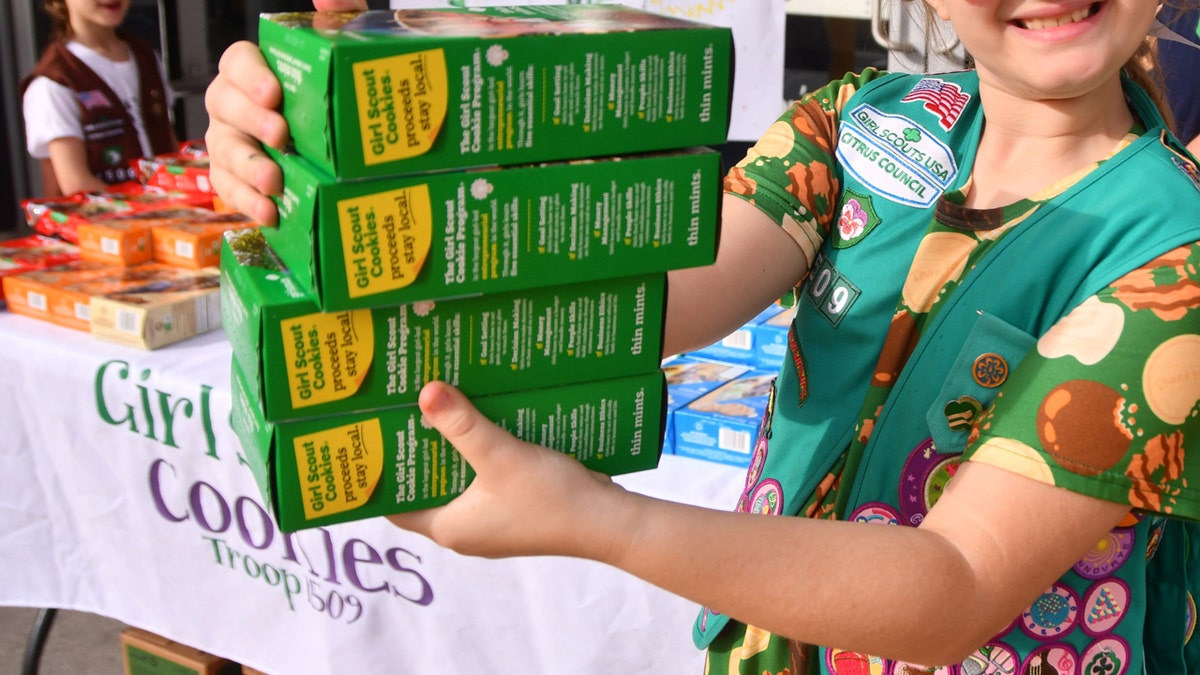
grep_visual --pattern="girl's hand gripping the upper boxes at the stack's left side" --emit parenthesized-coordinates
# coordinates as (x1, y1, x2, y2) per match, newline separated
(204, 0, 366, 225)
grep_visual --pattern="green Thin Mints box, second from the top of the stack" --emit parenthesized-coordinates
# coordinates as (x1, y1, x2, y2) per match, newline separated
(262, 148, 721, 311)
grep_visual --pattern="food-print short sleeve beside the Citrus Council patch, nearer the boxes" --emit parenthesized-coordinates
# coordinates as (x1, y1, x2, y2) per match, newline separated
(725, 68, 878, 267)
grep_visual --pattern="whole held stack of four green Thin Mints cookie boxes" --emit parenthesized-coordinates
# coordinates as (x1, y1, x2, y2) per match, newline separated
(222, 5, 732, 531)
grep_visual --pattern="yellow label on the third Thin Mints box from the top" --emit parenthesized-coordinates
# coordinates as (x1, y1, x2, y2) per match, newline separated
(280, 310, 374, 408)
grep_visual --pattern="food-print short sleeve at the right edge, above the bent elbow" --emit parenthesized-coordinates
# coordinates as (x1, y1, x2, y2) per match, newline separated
(965, 244, 1200, 520)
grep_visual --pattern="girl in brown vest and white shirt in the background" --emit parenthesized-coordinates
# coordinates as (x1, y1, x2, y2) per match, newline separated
(22, 0, 178, 196)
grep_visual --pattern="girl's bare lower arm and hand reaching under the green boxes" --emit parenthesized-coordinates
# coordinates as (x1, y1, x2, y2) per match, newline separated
(390, 383, 1129, 665)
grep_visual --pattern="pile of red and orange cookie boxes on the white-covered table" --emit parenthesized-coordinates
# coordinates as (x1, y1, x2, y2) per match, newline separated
(0, 141, 253, 350)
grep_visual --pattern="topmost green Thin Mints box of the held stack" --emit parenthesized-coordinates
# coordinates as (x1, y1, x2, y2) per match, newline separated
(258, 5, 733, 179)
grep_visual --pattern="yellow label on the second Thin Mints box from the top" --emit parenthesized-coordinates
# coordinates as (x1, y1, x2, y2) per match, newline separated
(337, 185, 433, 298)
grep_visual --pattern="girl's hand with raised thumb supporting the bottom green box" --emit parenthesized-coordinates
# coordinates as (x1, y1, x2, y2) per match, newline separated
(389, 382, 631, 560)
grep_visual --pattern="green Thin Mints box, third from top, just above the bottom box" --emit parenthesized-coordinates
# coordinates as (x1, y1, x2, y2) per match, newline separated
(221, 228, 666, 422)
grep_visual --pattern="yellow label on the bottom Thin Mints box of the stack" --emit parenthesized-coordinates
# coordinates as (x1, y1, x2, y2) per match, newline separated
(293, 419, 384, 520)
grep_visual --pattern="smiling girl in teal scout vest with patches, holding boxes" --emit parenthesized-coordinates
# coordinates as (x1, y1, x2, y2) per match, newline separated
(208, 0, 1200, 675)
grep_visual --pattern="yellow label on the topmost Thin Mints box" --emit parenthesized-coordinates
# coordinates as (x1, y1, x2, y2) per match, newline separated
(354, 49, 450, 166)
